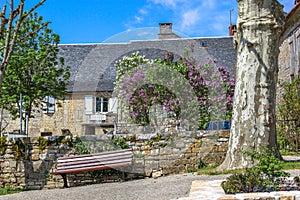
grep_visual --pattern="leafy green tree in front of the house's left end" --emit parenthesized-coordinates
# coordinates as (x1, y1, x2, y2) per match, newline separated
(0, 13, 69, 133)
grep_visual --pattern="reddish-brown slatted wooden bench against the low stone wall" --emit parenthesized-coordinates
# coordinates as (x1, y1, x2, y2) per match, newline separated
(51, 149, 132, 187)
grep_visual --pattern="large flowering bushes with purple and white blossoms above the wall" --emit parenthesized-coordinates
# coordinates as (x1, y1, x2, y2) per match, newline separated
(115, 47, 235, 129)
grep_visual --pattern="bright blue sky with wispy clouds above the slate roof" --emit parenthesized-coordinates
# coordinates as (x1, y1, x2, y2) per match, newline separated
(11, 0, 294, 44)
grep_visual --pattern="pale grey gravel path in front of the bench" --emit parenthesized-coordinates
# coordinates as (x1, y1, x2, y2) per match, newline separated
(0, 174, 226, 200)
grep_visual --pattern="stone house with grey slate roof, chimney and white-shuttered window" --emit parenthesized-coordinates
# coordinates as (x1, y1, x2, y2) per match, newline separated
(1, 23, 236, 136)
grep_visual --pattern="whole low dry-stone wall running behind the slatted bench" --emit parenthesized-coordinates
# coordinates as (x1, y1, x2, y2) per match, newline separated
(0, 131, 229, 189)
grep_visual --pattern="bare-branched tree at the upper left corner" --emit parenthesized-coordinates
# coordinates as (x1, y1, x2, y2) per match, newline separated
(0, 0, 46, 91)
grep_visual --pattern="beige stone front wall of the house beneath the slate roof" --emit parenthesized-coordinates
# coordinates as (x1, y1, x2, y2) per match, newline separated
(3, 92, 115, 137)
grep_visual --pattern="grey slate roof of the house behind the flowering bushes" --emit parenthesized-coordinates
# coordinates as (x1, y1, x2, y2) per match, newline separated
(59, 37, 236, 92)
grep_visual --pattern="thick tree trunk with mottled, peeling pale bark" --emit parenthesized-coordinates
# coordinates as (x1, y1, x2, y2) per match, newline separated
(219, 0, 284, 170)
